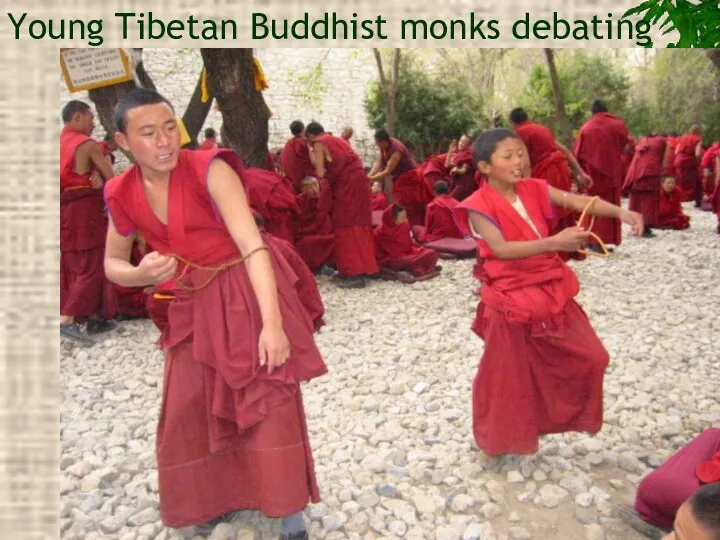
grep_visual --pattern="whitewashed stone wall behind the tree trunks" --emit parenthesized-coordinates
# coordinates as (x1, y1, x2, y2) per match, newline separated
(58, 48, 377, 168)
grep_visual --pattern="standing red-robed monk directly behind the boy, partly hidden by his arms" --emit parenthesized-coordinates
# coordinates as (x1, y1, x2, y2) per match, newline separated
(509, 107, 592, 260)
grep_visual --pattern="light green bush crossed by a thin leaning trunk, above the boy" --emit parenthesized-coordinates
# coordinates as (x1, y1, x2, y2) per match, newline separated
(517, 51, 630, 136)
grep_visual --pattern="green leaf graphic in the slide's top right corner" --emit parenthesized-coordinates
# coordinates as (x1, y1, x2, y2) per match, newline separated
(623, 0, 720, 49)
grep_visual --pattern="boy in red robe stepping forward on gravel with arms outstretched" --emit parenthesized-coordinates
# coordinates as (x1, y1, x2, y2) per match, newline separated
(455, 129, 643, 456)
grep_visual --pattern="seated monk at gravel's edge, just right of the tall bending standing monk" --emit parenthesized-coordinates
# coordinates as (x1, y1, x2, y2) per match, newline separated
(375, 204, 440, 276)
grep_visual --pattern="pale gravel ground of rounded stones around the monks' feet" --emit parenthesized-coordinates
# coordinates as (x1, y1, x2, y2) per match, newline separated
(60, 205, 720, 540)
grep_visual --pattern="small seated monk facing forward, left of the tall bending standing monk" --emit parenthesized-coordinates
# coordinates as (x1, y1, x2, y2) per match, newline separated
(295, 176, 335, 273)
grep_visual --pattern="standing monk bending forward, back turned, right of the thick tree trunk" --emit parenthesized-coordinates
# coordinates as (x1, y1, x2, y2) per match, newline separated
(305, 122, 380, 288)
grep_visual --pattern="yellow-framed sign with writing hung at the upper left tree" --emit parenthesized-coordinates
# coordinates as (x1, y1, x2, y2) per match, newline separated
(60, 49, 134, 92)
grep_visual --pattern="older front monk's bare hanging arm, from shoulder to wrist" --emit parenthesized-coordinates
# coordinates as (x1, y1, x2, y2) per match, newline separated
(208, 159, 282, 327)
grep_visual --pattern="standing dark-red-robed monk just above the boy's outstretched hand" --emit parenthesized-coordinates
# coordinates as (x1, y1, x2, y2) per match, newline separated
(623, 134, 670, 238)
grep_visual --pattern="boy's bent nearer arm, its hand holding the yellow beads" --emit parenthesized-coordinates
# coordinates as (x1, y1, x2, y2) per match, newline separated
(470, 212, 590, 260)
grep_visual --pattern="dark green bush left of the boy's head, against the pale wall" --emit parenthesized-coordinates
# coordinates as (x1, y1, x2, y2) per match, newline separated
(365, 55, 485, 160)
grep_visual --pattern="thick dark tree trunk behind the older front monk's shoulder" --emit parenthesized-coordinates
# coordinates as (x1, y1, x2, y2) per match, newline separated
(200, 49, 270, 167)
